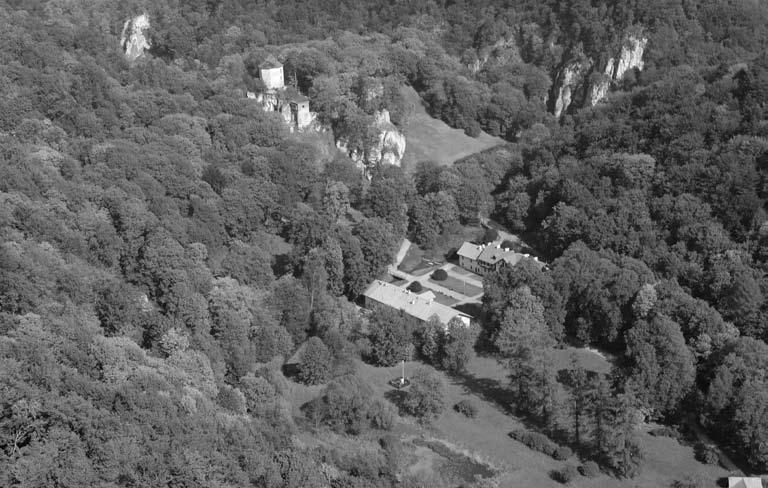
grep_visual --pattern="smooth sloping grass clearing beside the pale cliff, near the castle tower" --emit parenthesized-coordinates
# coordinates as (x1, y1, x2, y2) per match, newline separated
(403, 86, 505, 171)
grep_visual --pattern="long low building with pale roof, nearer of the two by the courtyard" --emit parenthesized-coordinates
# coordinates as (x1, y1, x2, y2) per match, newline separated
(363, 280, 472, 325)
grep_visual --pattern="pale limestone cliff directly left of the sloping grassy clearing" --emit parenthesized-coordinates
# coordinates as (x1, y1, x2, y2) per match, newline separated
(336, 109, 405, 172)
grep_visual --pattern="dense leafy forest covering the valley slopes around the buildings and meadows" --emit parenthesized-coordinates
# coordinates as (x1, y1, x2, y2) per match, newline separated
(0, 0, 768, 488)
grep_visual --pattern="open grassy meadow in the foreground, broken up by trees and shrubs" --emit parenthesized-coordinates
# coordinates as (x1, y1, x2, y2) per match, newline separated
(290, 348, 728, 488)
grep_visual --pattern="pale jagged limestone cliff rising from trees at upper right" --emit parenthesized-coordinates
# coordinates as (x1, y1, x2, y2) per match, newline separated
(550, 34, 648, 117)
